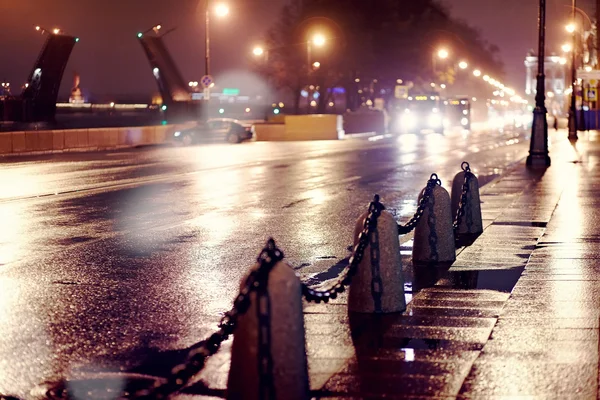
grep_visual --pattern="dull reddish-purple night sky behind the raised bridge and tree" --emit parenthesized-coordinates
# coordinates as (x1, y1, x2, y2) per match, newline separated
(0, 0, 595, 96)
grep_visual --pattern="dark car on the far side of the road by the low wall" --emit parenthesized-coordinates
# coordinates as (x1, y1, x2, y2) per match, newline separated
(173, 118, 253, 146)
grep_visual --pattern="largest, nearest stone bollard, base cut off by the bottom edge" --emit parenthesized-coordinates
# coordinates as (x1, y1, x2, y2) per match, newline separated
(227, 255, 310, 400)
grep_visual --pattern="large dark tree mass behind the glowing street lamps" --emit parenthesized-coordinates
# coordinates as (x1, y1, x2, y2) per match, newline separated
(262, 0, 502, 113)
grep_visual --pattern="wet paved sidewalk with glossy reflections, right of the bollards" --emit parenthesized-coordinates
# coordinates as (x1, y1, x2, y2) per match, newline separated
(292, 132, 600, 399)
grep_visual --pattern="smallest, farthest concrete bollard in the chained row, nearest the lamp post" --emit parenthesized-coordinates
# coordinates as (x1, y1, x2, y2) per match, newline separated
(452, 162, 483, 242)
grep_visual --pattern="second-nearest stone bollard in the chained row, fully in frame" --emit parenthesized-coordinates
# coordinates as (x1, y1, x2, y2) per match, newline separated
(348, 205, 406, 313)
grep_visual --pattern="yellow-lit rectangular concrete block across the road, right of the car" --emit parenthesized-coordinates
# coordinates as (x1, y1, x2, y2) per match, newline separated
(285, 114, 344, 140)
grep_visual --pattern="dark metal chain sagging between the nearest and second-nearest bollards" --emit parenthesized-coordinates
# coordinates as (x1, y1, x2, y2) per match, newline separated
(302, 194, 385, 303)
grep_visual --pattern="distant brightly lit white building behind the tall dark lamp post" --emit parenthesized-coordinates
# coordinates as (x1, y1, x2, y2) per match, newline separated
(525, 51, 569, 114)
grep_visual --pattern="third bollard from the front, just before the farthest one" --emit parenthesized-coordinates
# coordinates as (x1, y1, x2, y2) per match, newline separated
(413, 174, 456, 264)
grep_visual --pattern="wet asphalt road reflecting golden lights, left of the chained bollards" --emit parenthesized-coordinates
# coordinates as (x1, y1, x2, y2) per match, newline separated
(0, 126, 540, 397)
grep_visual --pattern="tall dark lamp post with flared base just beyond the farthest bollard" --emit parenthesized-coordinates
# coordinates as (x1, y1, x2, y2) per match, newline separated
(526, 0, 550, 167)
